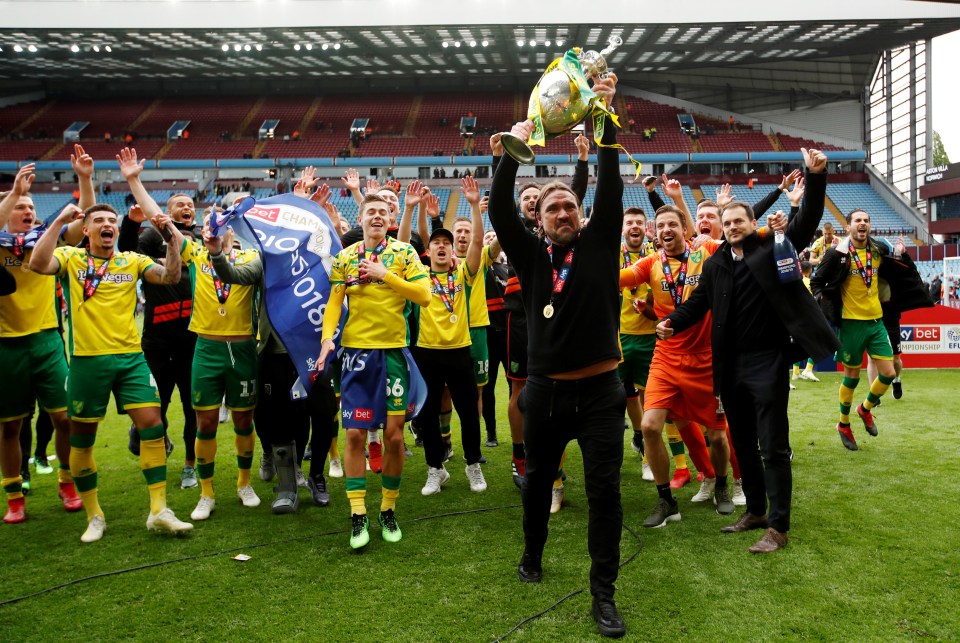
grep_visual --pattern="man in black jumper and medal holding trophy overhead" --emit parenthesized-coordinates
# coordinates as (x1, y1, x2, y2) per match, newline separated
(490, 37, 626, 637)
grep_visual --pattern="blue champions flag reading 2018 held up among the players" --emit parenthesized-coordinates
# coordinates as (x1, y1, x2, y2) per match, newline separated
(225, 194, 347, 399)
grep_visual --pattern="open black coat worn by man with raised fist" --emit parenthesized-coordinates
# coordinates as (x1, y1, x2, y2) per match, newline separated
(667, 174, 840, 392)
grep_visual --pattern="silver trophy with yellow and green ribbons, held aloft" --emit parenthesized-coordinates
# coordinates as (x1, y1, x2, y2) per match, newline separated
(500, 36, 623, 165)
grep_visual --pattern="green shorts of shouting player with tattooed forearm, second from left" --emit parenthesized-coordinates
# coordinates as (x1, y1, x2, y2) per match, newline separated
(67, 353, 160, 422)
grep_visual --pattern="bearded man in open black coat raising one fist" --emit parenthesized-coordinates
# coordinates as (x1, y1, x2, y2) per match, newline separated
(657, 150, 839, 553)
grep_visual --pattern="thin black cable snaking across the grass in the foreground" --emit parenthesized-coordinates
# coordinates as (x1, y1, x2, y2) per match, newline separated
(0, 505, 643, 643)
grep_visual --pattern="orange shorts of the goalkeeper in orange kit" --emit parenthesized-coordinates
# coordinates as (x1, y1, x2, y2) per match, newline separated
(643, 346, 726, 430)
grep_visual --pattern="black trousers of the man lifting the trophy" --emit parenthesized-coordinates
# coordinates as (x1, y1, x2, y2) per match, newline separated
(523, 370, 627, 598)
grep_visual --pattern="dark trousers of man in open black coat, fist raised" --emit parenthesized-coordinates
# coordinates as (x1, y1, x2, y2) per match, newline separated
(720, 350, 793, 532)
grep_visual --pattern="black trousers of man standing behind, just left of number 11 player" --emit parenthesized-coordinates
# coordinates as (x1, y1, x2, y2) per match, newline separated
(143, 342, 197, 461)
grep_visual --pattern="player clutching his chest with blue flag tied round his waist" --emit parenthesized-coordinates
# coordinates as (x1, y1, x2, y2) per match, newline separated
(318, 194, 431, 549)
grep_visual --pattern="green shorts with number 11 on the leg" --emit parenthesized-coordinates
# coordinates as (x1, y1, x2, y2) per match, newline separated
(190, 337, 257, 411)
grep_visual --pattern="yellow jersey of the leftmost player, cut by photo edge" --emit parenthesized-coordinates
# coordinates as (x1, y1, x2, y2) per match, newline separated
(0, 248, 57, 337)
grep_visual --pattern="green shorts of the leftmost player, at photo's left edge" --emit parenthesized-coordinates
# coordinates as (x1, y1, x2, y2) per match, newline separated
(0, 328, 68, 422)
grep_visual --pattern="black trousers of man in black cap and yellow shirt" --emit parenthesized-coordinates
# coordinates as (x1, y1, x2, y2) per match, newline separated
(412, 346, 480, 469)
